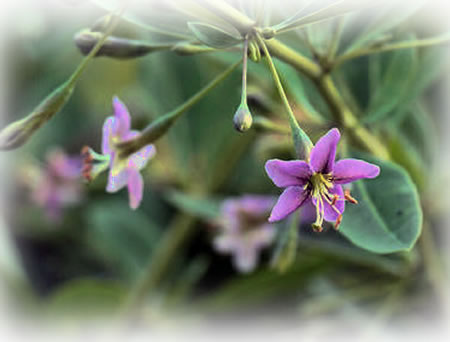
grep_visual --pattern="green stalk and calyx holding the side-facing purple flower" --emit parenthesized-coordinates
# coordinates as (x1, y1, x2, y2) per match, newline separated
(117, 60, 241, 157)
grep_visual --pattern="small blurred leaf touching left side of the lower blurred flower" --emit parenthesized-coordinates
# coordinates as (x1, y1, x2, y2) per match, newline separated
(166, 190, 221, 220)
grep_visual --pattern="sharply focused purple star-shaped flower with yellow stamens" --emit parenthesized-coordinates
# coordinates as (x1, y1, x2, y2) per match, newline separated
(266, 128, 380, 231)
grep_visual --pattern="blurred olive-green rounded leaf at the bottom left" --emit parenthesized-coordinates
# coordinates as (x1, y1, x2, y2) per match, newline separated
(47, 278, 126, 317)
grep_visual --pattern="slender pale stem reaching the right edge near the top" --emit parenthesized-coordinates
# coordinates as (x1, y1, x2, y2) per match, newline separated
(333, 34, 450, 67)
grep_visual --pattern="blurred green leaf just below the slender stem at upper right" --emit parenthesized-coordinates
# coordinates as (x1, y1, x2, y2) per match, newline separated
(364, 37, 418, 122)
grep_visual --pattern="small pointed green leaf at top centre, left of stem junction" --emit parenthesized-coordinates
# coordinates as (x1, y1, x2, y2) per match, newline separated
(188, 22, 242, 49)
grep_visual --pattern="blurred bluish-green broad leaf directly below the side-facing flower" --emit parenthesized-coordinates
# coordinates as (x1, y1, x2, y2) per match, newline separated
(87, 200, 159, 279)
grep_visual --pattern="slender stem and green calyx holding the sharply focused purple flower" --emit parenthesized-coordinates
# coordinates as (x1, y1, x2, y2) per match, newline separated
(256, 34, 313, 159)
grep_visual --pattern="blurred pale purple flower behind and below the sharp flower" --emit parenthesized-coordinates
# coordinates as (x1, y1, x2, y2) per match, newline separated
(214, 195, 275, 273)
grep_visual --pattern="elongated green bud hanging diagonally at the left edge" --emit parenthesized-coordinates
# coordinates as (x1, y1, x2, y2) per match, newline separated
(0, 82, 74, 150)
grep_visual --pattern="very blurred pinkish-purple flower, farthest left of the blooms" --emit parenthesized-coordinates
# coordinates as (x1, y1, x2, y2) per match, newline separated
(27, 149, 82, 221)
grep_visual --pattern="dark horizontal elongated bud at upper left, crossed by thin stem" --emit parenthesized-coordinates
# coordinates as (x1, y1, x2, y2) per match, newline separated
(74, 29, 172, 59)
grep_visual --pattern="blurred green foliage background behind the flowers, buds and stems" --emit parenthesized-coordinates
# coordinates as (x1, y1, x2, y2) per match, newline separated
(2, 2, 448, 334)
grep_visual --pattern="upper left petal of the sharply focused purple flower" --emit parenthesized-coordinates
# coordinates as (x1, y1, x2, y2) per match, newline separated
(266, 159, 311, 188)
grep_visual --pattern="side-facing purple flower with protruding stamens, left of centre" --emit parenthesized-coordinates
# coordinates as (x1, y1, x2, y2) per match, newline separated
(83, 97, 156, 209)
